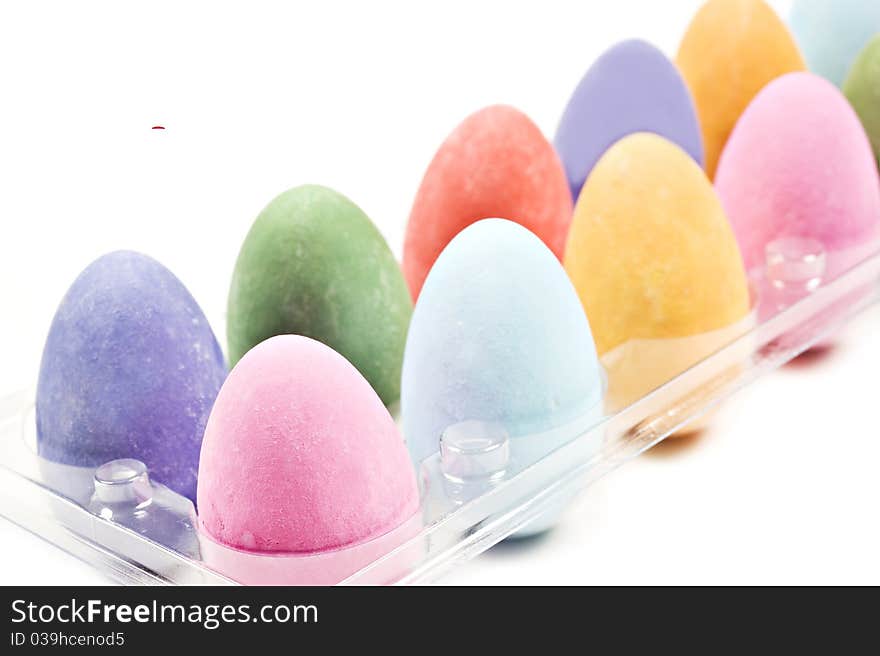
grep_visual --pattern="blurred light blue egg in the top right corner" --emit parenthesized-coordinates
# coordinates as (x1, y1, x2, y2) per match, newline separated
(790, 0, 880, 86)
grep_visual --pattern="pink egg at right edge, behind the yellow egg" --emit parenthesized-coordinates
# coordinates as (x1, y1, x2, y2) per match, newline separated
(715, 73, 880, 280)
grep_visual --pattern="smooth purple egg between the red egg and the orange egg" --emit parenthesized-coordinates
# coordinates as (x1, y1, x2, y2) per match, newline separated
(554, 40, 703, 201)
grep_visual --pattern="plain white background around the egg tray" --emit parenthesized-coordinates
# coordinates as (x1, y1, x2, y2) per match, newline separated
(6, 0, 880, 583)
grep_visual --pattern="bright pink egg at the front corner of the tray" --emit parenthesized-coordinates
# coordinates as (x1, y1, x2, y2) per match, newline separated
(198, 335, 419, 555)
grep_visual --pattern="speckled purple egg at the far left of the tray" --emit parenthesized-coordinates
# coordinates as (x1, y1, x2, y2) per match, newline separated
(36, 251, 226, 500)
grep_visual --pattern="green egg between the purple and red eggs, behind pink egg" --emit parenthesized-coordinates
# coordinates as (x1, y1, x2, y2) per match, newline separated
(227, 185, 412, 405)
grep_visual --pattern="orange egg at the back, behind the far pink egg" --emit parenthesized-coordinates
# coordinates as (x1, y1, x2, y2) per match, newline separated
(675, 0, 805, 178)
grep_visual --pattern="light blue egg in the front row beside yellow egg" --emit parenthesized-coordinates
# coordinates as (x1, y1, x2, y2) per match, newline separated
(401, 219, 603, 532)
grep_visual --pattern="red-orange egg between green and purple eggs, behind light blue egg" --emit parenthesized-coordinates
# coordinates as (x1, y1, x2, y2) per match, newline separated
(403, 105, 571, 299)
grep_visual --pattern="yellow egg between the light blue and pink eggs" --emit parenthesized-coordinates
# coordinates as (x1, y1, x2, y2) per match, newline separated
(564, 133, 751, 416)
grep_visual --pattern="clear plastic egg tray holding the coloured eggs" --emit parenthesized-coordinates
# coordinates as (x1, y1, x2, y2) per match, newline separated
(0, 239, 880, 584)
